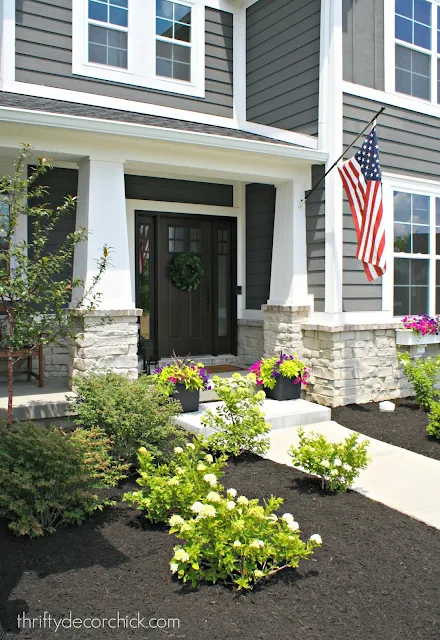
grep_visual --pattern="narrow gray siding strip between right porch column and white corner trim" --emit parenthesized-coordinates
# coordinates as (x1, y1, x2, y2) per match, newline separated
(306, 165, 325, 311)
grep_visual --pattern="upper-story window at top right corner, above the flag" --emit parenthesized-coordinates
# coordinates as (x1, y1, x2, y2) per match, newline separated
(395, 0, 440, 102)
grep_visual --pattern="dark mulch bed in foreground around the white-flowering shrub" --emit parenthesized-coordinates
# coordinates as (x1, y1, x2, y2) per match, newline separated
(0, 457, 440, 640)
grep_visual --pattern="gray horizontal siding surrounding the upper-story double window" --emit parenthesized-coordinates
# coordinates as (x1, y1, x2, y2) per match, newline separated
(15, 0, 233, 117)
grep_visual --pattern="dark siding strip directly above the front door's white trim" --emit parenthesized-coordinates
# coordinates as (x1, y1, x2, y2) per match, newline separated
(125, 175, 234, 207)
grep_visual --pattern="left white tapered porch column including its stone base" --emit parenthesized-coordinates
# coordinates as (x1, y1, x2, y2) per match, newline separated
(70, 158, 141, 378)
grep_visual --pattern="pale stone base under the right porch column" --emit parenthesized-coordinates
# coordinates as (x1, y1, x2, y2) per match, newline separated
(262, 304, 310, 358)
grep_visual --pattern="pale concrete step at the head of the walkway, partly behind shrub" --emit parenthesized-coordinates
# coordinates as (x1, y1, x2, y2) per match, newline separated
(174, 400, 331, 436)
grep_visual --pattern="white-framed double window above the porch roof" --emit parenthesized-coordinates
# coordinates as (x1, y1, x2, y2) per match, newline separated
(72, 0, 205, 97)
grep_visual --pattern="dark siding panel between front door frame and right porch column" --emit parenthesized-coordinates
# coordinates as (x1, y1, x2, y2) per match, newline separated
(246, 184, 276, 309)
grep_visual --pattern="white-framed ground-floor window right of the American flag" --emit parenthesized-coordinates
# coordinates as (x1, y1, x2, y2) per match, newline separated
(393, 190, 440, 316)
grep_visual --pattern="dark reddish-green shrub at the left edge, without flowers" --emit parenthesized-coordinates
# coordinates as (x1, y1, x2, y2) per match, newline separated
(0, 422, 126, 537)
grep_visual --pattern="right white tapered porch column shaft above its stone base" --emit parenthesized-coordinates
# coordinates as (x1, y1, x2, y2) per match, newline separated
(267, 181, 313, 306)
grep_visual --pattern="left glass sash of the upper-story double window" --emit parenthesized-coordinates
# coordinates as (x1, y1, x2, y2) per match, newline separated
(88, 0, 128, 69)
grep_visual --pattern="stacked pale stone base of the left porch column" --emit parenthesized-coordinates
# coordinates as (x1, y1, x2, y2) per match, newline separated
(70, 309, 142, 379)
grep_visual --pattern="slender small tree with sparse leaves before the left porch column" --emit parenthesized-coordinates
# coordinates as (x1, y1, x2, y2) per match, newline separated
(0, 144, 109, 426)
